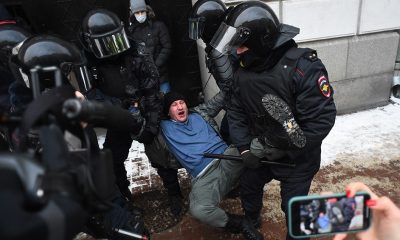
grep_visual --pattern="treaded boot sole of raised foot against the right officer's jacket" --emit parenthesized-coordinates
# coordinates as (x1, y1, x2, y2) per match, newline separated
(262, 94, 306, 148)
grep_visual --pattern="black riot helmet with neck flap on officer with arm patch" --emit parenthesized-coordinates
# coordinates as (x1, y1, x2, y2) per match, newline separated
(210, 1, 299, 56)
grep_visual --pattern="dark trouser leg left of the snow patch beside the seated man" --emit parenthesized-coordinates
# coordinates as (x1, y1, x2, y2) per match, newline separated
(103, 129, 132, 200)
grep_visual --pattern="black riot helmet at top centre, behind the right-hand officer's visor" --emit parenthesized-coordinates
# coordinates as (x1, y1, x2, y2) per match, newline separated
(189, 0, 226, 44)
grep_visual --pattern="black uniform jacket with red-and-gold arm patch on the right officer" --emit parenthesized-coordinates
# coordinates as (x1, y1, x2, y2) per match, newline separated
(228, 47, 336, 177)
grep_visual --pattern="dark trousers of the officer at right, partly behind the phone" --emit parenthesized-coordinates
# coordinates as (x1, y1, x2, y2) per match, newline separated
(240, 166, 314, 239)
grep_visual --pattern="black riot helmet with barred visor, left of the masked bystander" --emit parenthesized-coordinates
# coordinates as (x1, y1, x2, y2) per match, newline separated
(82, 9, 130, 58)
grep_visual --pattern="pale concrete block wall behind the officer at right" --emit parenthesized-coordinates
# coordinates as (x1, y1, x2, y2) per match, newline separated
(199, 0, 400, 113)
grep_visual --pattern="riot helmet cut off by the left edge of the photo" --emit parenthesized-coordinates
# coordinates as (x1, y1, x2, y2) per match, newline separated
(0, 22, 31, 71)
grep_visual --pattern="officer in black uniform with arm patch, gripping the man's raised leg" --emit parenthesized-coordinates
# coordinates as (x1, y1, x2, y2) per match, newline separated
(211, 1, 336, 238)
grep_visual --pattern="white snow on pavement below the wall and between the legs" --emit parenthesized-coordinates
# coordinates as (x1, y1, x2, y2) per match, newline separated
(99, 98, 400, 192)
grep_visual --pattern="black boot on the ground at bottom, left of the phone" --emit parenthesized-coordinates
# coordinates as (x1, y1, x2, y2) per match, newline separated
(225, 214, 264, 240)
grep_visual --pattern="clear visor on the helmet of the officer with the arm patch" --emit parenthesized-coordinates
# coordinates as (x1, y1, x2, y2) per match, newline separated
(210, 22, 250, 54)
